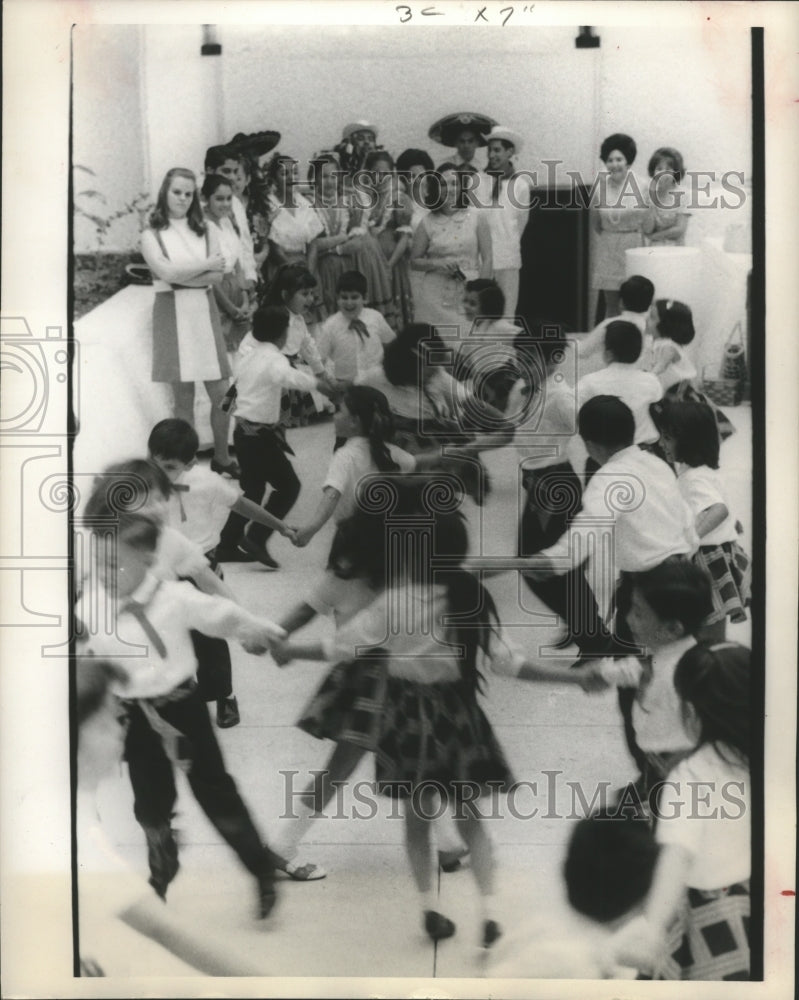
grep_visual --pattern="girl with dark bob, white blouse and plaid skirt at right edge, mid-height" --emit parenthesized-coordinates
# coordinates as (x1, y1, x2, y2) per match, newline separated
(661, 400, 752, 642)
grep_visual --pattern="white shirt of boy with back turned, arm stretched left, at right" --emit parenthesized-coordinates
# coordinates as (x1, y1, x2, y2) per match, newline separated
(541, 445, 698, 573)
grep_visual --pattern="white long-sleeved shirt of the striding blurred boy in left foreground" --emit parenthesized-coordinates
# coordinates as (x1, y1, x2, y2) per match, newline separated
(78, 573, 285, 698)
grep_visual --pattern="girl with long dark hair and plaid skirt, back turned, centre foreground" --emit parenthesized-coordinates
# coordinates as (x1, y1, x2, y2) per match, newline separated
(273, 480, 512, 947)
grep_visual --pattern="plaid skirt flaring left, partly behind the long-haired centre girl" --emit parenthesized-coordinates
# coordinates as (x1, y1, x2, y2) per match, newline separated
(297, 657, 388, 750)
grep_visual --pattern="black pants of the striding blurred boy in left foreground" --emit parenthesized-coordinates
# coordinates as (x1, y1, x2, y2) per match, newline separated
(125, 690, 270, 876)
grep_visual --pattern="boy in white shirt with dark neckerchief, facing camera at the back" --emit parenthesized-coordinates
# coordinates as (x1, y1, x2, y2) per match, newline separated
(316, 271, 396, 389)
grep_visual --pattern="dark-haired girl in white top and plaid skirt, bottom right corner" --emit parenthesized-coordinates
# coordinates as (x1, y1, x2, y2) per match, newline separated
(614, 643, 751, 980)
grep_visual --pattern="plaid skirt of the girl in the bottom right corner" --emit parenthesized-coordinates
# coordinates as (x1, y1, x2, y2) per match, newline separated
(655, 880, 750, 980)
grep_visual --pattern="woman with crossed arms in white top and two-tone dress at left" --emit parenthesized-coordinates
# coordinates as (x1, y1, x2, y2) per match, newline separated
(141, 167, 238, 475)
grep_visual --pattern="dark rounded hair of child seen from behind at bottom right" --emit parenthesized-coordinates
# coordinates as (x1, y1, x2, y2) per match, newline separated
(563, 810, 658, 923)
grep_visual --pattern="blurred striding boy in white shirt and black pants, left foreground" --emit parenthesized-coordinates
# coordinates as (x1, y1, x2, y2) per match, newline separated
(78, 512, 282, 917)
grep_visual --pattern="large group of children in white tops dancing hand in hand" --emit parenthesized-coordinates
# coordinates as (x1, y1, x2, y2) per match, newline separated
(77, 254, 750, 978)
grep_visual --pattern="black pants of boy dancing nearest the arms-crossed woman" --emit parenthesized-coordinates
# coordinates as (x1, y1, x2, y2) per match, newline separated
(220, 424, 300, 548)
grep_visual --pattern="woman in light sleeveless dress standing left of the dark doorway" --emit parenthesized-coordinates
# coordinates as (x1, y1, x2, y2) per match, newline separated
(411, 163, 493, 327)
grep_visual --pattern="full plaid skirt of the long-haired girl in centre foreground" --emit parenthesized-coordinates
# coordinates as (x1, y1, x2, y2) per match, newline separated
(375, 677, 513, 801)
